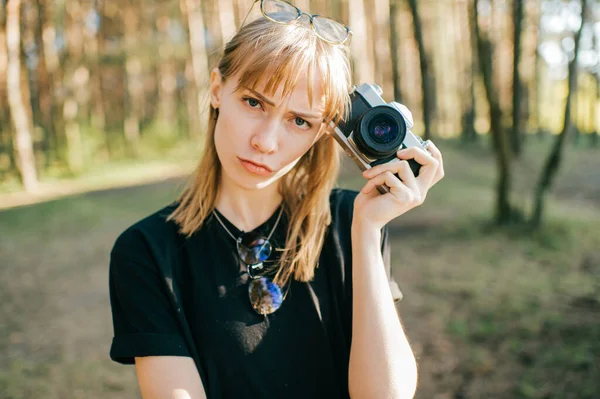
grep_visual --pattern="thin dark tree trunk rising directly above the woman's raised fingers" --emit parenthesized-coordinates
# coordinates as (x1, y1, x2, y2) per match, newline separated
(408, 0, 435, 140)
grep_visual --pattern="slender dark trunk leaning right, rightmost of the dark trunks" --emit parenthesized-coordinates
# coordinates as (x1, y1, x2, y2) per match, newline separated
(531, 0, 587, 227)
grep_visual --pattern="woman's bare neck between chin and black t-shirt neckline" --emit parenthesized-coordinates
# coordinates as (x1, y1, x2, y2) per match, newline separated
(215, 176, 283, 231)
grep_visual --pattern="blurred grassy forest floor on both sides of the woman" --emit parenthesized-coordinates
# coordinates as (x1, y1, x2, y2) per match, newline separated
(0, 140, 600, 399)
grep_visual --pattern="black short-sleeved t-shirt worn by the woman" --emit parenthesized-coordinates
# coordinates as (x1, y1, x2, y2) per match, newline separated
(109, 189, 401, 399)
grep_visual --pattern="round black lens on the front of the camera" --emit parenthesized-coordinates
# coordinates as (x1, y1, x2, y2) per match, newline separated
(353, 105, 406, 158)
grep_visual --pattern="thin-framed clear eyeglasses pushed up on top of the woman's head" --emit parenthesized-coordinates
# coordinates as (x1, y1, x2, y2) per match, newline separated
(242, 0, 352, 44)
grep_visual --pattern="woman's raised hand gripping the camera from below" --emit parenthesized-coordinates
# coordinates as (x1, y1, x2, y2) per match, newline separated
(352, 142, 444, 229)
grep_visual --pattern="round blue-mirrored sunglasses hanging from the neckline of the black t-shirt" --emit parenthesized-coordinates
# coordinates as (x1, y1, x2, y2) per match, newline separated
(212, 206, 284, 316)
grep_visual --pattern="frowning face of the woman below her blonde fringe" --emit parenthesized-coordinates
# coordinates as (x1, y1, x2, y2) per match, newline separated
(210, 69, 325, 189)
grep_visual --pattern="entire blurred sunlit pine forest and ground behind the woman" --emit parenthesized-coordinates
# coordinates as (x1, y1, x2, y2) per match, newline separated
(0, 0, 600, 399)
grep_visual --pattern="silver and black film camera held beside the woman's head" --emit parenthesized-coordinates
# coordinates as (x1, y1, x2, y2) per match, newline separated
(329, 83, 424, 194)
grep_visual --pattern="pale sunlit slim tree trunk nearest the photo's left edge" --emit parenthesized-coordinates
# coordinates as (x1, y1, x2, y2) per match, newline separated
(6, 0, 38, 192)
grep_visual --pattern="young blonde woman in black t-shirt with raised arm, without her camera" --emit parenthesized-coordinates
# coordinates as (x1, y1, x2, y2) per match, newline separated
(110, 0, 443, 399)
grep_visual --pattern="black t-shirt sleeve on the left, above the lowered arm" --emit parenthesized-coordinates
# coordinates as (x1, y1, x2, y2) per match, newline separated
(109, 230, 191, 364)
